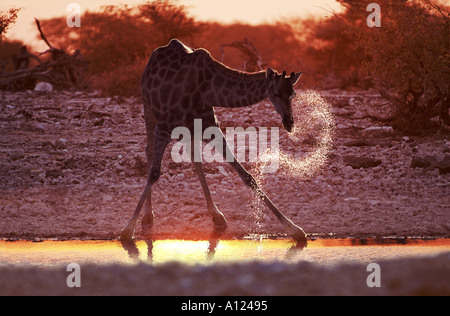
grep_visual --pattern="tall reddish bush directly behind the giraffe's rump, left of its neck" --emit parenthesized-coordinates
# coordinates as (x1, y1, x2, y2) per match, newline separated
(38, 0, 203, 96)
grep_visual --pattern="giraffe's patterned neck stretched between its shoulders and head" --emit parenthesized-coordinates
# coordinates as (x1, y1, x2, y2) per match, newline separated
(206, 62, 269, 108)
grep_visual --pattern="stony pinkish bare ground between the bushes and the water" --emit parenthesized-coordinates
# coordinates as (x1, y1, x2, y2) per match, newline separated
(0, 90, 450, 239)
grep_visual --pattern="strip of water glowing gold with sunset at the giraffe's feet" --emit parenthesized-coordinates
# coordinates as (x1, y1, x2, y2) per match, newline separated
(0, 238, 450, 266)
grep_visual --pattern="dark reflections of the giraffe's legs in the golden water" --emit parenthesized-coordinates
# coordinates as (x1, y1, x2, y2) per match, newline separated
(120, 230, 307, 263)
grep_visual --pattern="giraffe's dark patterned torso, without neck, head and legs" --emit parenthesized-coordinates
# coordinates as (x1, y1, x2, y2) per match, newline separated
(141, 40, 216, 128)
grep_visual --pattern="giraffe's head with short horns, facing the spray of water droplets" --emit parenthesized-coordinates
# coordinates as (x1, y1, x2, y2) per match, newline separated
(266, 68, 302, 133)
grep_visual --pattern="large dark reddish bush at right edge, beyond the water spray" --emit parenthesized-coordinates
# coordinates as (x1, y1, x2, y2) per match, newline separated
(339, 0, 450, 134)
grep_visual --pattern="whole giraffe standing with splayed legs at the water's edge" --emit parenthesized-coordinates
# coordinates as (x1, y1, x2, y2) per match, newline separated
(120, 39, 307, 242)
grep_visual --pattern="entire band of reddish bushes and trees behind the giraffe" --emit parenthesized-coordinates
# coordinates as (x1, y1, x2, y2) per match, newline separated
(1, 0, 450, 133)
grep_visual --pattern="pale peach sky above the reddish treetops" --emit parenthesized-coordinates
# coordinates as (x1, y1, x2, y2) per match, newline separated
(0, 0, 339, 48)
